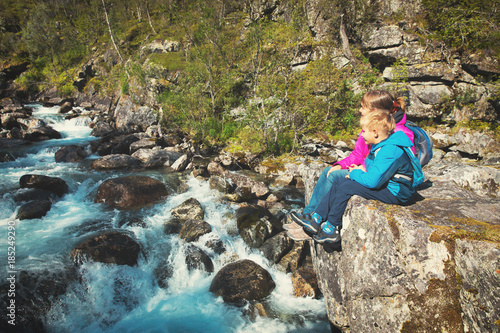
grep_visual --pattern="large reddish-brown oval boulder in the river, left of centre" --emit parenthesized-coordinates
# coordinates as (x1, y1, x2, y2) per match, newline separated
(94, 176, 168, 210)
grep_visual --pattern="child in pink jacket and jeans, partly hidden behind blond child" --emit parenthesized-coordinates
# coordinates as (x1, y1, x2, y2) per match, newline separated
(283, 90, 415, 230)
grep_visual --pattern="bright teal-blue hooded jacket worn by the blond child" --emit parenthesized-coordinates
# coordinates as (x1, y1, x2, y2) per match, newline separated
(349, 131, 415, 202)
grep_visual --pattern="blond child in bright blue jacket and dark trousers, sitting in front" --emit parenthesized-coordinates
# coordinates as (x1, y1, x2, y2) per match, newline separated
(289, 110, 422, 243)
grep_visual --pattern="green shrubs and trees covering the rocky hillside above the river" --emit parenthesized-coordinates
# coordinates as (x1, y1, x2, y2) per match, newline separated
(0, 0, 500, 155)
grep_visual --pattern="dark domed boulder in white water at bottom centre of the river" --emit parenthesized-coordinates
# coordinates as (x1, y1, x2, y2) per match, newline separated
(209, 259, 276, 303)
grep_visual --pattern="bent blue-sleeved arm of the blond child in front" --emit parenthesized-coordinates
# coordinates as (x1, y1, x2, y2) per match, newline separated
(349, 147, 404, 189)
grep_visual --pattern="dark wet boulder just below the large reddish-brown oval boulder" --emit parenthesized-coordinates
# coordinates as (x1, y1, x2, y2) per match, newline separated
(71, 231, 141, 266)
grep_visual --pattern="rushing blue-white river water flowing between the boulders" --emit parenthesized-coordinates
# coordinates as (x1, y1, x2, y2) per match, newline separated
(0, 105, 330, 333)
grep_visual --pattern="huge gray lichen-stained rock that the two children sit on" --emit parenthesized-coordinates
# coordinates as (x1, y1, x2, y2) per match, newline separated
(304, 161, 500, 332)
